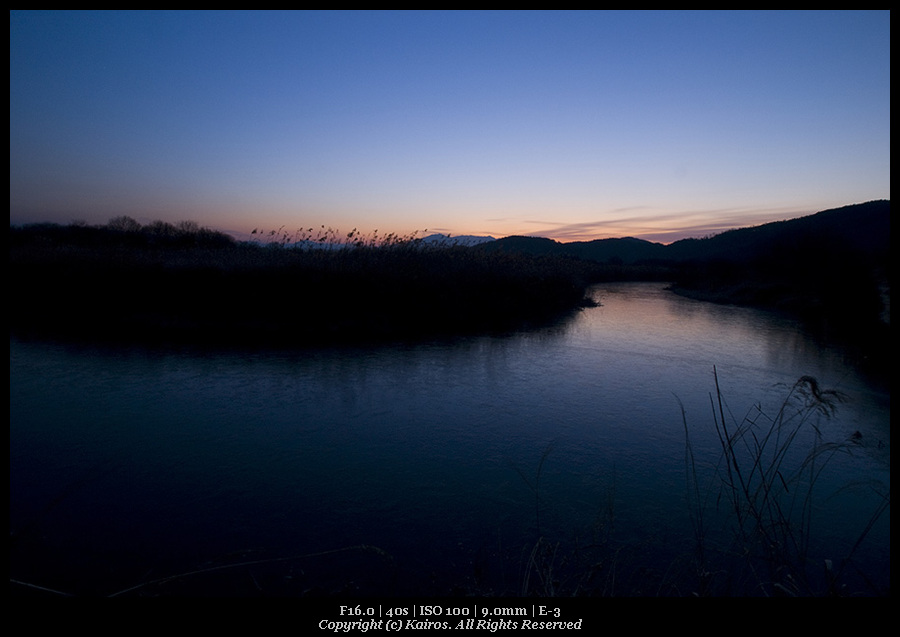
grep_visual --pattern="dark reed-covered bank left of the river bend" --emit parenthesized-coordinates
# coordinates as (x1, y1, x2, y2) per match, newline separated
(10, 217, 604, 347)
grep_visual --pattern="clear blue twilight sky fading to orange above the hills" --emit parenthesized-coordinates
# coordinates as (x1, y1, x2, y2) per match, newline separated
(9, 11, 890, 243)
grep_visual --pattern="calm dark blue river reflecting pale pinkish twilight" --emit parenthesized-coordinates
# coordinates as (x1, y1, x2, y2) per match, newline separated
(10, 284, 890, 595)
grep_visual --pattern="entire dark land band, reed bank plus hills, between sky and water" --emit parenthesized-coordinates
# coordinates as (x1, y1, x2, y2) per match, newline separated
(10, 201, 890, 360)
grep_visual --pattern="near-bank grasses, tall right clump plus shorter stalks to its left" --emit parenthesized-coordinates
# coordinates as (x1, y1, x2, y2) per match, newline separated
(516, 368, 890, 597)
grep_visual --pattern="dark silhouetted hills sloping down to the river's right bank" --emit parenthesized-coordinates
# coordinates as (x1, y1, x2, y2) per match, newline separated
(475, 200, 891, 378)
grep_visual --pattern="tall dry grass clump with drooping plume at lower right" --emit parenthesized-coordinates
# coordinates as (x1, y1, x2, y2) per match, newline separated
(682, 369, 890, 596)
